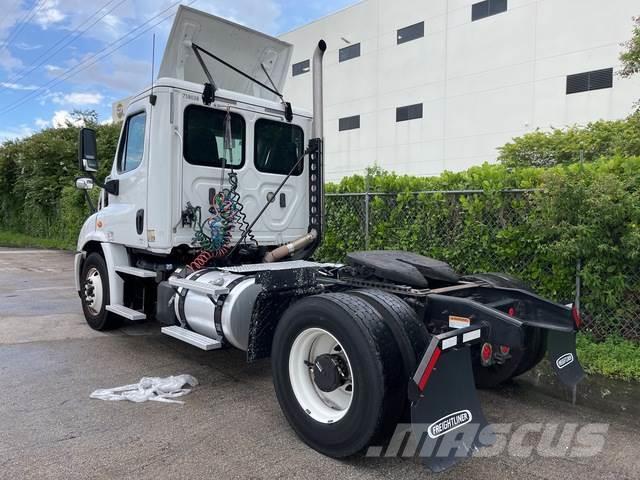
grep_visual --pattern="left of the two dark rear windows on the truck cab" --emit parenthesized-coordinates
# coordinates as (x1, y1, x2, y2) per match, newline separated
(183, 105, 245, 168)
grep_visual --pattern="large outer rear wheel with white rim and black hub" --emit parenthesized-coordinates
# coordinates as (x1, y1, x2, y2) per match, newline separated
(271, 293, 406, 458)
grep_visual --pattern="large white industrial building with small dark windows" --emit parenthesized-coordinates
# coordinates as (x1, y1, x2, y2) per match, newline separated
(280, 0, 640, 180)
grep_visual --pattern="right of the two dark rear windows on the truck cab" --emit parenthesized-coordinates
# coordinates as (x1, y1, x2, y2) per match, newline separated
(254, 118, 304, 175)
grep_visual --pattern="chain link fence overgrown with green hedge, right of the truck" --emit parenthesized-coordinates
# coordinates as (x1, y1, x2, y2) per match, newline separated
(318, 190, 640, 340)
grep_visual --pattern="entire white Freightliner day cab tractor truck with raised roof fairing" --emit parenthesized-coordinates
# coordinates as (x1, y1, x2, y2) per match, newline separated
(75, 7, 583, 470)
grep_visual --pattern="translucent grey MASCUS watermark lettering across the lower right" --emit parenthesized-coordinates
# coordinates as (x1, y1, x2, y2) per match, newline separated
(367, 424, 609, 458)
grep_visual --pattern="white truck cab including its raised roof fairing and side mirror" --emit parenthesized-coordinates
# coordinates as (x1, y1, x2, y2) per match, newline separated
(75, 7, 323, 318)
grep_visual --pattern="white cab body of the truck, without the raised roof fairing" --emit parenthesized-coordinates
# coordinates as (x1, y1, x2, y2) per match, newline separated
(78, 77, 311, 255)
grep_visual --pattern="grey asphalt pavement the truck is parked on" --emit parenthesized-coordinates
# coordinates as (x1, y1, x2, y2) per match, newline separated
(0, 248, 640, 480)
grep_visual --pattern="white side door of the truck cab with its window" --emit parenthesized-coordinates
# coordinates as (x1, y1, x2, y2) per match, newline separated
(97, 104, 150, 247)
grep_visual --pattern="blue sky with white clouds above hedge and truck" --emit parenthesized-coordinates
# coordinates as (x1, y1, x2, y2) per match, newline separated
(0, 0, 356, 142)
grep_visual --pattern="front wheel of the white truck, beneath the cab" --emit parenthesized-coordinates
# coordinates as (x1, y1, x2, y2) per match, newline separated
(80, 252, 122, 331)
